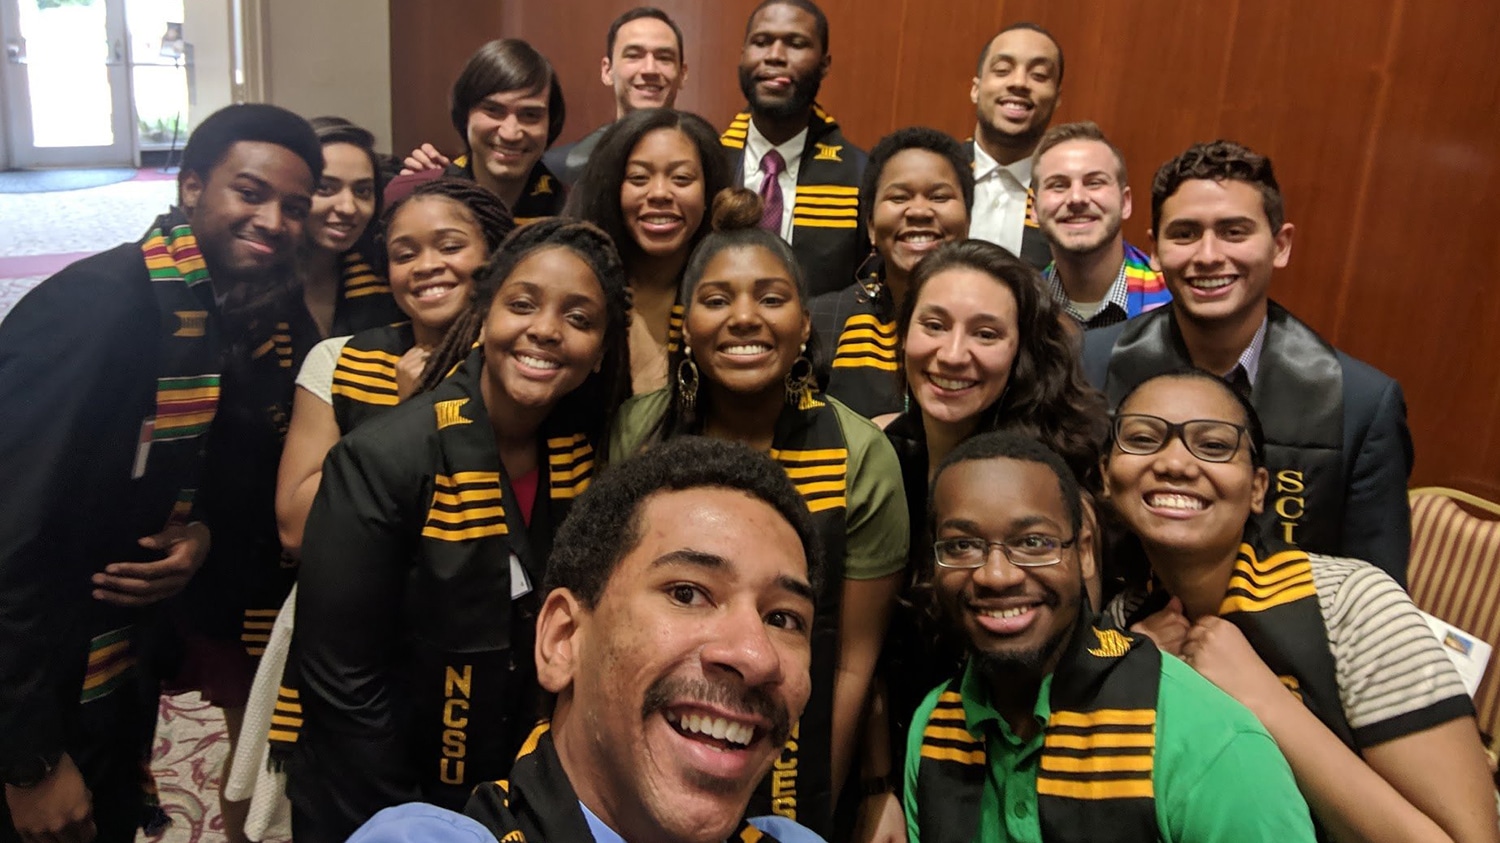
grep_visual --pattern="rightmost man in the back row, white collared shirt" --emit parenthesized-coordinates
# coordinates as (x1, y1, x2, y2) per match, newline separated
(969, 23, 1064, 269)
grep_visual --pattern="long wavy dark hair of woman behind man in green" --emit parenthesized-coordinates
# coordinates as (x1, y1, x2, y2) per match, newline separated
(896, 240, 1109, 486)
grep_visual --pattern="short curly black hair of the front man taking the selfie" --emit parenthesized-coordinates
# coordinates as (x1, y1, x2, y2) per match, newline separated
(543, 437, 824, 609)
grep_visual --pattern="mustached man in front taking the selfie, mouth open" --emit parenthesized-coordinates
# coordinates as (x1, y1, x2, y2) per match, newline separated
(350, 437, 824, 843)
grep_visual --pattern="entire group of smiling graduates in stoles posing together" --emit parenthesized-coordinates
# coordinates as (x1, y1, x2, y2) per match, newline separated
(0, 0, 1500, 843)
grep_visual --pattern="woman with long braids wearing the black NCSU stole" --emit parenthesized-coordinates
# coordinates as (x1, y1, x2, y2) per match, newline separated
(287, 219, 627, 843)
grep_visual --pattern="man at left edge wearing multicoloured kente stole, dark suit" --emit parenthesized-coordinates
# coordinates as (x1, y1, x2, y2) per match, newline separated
(0, 105, 323, 843)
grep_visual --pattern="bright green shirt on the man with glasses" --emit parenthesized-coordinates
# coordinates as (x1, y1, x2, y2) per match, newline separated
(905, 653, 1316, 843)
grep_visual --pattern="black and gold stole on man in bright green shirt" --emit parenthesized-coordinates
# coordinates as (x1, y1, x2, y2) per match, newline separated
(917, 620, 1161, 843)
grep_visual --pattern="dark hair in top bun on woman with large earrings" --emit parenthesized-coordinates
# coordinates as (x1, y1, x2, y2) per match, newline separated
(647, 188, 818, 443)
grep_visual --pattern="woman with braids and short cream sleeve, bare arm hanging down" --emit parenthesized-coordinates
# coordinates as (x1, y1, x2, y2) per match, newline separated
(276, 179, 515, 557)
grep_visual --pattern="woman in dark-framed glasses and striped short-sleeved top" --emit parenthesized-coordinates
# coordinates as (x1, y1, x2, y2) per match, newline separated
(1104, 369, 1500, 843)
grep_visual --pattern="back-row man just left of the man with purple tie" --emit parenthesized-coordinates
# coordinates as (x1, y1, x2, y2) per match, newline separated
(542, 6, 687, 188)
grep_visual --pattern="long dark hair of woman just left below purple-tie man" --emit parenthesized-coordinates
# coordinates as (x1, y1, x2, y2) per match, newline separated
(563, 108, 732, 264)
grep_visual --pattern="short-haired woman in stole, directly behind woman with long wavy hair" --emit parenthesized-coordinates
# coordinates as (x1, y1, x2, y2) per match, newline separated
(809, 126, 974, 417)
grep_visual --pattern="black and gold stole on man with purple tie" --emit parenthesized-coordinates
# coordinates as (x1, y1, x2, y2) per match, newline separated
(719, 104, 864, 296)
